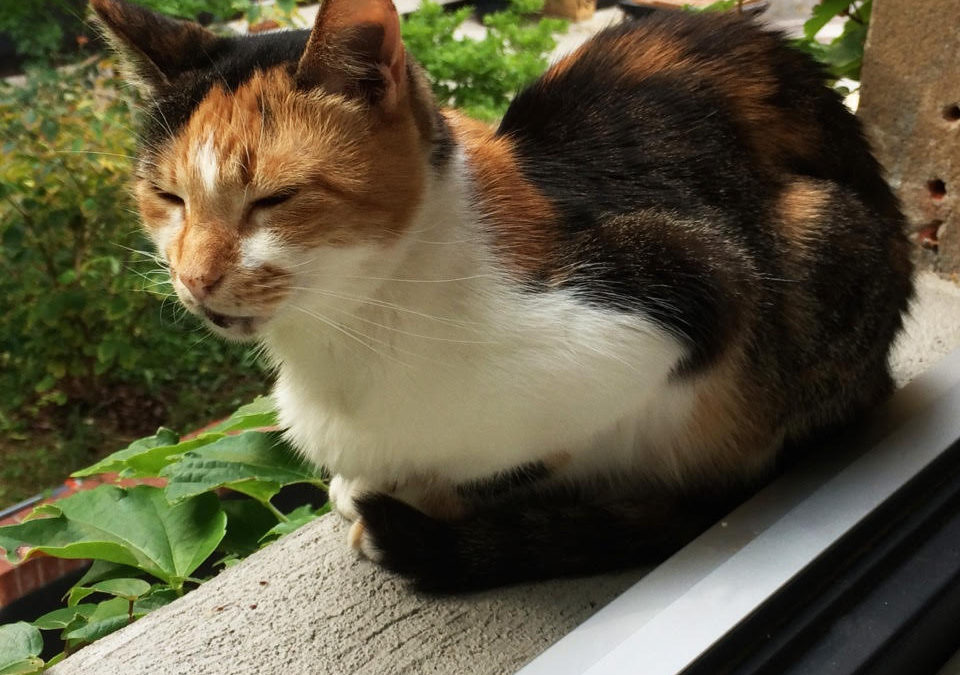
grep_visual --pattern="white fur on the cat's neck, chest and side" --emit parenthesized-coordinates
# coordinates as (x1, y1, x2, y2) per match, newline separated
(255, 149, 693, 489)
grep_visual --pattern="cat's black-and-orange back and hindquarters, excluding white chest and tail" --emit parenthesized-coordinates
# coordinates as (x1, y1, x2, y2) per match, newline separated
(497, 12, 911, 438)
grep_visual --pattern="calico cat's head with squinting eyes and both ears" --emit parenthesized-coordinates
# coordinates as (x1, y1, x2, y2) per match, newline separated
(91, 0, 443, 339)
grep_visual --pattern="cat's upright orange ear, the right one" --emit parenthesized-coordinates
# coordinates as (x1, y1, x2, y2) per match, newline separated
(296, 0, 408, 112)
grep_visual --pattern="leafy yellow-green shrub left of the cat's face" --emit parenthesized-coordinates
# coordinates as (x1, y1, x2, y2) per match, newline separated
(0, 61, 259, 486)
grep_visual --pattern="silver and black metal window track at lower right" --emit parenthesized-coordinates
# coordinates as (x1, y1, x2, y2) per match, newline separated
(520, 350, 960, 675)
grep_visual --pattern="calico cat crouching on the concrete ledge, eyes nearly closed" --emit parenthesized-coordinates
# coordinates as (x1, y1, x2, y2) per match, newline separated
(92, 0, 912, 591)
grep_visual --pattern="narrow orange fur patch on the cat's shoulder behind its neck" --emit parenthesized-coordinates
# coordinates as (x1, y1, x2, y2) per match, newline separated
(445, 111, 557, 277)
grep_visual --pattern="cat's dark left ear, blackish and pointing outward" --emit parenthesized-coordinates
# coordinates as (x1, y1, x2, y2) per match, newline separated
(90, 0, 217, 95)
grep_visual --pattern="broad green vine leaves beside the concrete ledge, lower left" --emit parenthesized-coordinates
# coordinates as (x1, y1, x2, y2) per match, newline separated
(0, 399, 329, 673)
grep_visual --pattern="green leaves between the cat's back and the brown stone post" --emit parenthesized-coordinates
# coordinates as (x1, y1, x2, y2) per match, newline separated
(794, 0, 873, 80)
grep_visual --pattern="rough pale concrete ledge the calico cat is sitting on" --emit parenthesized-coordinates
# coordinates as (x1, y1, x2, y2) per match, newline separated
(50, 274, 960, 675)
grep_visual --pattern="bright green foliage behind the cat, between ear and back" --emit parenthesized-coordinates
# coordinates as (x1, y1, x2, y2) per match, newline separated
(403, 0, 567, 120)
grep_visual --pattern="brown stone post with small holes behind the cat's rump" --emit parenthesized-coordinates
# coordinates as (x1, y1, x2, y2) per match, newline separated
(859, 0, 960, 272)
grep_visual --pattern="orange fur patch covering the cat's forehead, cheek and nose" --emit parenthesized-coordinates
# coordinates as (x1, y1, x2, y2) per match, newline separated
(138, 68, 425, 260)
